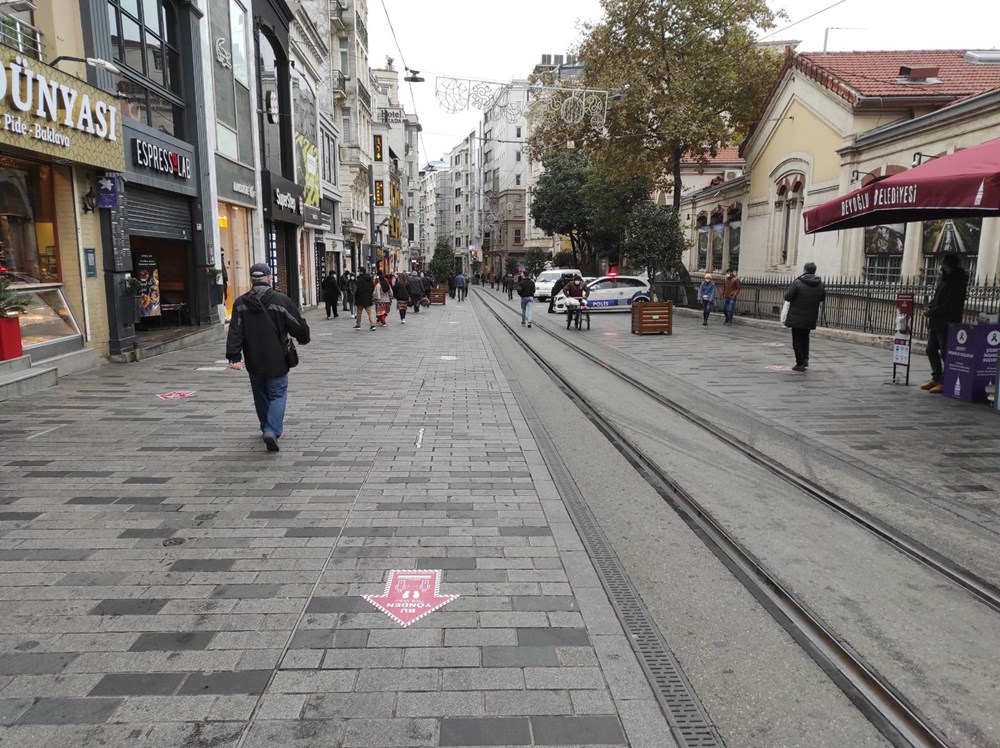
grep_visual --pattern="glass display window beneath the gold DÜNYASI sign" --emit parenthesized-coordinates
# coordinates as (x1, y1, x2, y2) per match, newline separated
(0, 156, 61, 285)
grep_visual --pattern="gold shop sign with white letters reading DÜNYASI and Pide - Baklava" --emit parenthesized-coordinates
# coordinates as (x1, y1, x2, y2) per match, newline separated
(0, 46, 125, 171)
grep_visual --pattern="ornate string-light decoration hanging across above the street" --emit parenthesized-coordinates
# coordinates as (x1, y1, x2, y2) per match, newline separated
(434, 76, 608, 128)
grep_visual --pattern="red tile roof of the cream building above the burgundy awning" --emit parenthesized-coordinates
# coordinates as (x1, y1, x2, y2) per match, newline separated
(793, 49, 1000, 106)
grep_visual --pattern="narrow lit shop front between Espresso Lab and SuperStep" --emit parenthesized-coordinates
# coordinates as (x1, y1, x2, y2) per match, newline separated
(215, 155, 257, 317)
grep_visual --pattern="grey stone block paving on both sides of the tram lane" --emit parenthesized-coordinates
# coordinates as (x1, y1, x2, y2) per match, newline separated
(0, 289, 1000, 747)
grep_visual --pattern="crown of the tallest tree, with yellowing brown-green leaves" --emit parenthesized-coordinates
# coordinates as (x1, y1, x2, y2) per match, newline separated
(529, 0, 784, 209)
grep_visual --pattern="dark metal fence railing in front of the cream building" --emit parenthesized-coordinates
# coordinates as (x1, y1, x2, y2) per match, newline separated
(655, 276, 1000, 339)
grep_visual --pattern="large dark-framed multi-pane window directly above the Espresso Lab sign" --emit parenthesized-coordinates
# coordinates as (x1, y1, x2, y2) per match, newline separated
(107, 0, 184, 137)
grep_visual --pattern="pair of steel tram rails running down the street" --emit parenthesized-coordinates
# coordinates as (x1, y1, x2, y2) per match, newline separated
(479, 295, 960, 746)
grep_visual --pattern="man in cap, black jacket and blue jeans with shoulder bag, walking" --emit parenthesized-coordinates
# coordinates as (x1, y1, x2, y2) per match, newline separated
(226, 262, 309, 452)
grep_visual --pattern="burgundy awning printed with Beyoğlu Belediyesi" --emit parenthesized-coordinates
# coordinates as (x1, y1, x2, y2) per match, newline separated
(802, 138, 1000, 234)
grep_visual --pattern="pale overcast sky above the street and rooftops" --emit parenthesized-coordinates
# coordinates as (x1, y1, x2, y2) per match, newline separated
(368, 0, 998, 163)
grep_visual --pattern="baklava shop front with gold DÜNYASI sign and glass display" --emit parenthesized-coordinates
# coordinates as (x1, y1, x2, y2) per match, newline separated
(0, 45, 123, 360)
